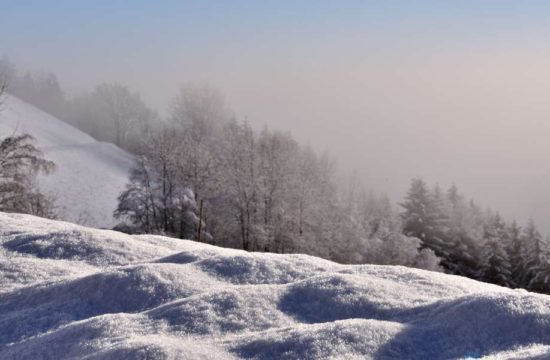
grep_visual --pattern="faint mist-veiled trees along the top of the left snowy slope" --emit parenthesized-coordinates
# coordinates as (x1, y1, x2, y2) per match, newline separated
(0, 57, 156, 152)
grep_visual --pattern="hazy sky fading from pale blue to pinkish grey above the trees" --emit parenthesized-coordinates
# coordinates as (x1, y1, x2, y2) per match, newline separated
(0, 0, 550, 233)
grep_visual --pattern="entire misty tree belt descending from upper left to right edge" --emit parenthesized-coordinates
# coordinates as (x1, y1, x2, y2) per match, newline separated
(0, 56, 550, 293)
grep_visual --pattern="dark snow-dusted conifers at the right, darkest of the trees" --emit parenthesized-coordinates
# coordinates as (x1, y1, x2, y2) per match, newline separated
(401, 179, 550, 293)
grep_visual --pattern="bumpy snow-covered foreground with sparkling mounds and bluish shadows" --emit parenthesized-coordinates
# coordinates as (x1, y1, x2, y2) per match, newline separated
(0, 213, 550, 360)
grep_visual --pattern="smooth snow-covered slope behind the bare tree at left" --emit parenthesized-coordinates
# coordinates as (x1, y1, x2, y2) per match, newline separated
(0, 95, 133, 227)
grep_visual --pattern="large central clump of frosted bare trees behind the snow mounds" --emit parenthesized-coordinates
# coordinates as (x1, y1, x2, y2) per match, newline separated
(115, 87, 439, 269)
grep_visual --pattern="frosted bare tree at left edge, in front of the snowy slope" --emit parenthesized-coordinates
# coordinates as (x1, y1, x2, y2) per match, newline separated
(0, 80, 55, 218)
